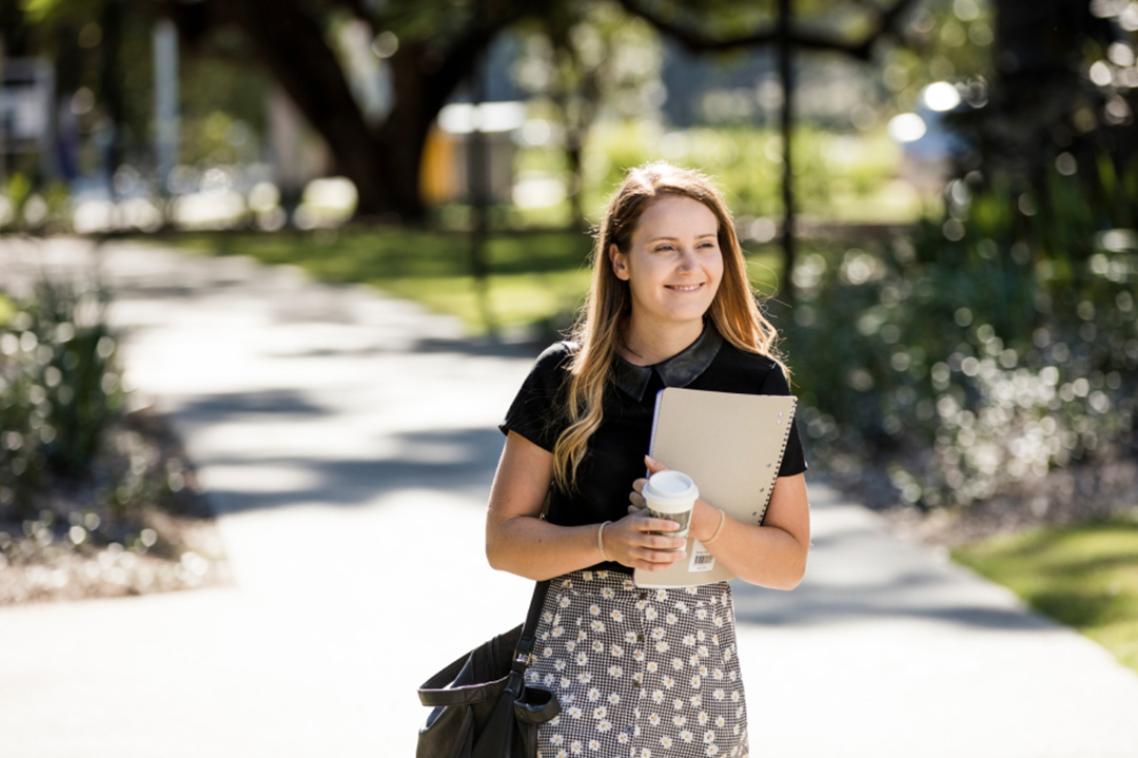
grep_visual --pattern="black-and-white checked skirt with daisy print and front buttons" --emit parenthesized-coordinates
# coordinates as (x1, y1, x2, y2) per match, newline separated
(526, 570, 748, 758)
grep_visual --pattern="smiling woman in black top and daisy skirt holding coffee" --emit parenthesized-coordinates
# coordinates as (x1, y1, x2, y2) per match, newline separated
(486, 163, 810, 758)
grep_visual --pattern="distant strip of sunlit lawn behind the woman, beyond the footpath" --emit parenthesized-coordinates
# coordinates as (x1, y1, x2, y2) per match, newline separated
(166, 228, 781, 335)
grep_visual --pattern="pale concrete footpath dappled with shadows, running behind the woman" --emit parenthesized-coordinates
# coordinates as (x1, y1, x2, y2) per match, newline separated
(0, 239, 1138, 758)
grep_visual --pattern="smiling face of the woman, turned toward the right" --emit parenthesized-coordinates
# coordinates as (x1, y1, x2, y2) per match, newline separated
(609, 196, 723, 323)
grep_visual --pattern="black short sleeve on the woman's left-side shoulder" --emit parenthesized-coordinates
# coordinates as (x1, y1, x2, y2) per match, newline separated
(498, 341, 572, 453)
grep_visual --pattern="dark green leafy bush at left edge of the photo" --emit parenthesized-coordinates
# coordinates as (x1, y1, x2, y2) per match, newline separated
(0, 280, 123, 518)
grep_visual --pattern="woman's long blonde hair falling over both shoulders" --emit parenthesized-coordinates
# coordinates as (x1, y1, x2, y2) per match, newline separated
(553, 162, 790, 492)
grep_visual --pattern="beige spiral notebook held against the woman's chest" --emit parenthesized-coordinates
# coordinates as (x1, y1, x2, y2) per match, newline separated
(633, 387, 798, 587)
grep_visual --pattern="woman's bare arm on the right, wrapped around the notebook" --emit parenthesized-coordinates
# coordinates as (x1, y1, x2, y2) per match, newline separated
(630, 459, 810, 590)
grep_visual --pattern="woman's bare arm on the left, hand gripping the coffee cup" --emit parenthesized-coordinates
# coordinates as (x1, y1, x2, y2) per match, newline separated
(486, 431, 684, 580)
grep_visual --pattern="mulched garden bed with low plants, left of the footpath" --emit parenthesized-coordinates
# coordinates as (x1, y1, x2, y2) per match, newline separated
(0, 406, 231, 605)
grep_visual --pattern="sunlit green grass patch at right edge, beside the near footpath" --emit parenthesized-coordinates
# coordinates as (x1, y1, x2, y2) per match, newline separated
(953, 513, 1138, 672)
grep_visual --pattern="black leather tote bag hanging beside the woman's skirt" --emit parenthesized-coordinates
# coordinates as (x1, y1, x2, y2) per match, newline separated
(415, 582, 561, 758)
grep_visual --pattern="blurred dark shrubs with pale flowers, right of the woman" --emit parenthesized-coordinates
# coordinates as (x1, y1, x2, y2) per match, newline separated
(787, 146, 1138, 506)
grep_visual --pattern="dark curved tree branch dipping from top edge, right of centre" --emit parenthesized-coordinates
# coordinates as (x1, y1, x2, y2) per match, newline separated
(618, 0, 916, 60)
